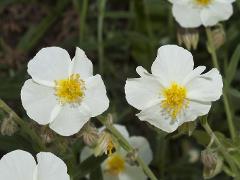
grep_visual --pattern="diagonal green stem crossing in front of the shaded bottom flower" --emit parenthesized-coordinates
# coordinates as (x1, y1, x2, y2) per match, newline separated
(98, 117, 157, 180)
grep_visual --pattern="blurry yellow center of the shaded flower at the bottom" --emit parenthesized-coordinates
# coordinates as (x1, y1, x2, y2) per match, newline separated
(106, 154, 125, 176)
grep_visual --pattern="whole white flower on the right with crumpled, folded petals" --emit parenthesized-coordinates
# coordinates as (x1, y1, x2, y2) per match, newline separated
(125, 45, 223, 132)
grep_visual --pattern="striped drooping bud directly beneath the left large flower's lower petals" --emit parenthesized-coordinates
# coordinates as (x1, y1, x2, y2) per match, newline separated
(80, 122, 98, 147)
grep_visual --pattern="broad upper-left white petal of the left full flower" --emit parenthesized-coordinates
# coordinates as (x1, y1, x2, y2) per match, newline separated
(28, 47, 71, 82)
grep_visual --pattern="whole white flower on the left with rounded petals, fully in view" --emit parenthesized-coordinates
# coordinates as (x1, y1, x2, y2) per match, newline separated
(21, 47, 109, 136)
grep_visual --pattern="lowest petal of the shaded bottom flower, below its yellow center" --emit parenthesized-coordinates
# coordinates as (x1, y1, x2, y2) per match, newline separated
(119, 164, 147, 180)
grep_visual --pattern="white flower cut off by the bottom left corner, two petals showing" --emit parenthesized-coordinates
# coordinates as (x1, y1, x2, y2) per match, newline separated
(0, 150, 70, 180)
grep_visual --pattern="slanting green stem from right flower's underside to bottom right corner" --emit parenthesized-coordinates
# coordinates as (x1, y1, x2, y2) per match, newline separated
(200, 117, 240, 178)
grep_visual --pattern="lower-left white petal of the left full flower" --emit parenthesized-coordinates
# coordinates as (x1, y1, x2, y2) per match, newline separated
(21, 79, 58, 125)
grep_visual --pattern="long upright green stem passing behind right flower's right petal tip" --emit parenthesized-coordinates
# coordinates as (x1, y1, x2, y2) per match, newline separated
(206, 28, 236, 140)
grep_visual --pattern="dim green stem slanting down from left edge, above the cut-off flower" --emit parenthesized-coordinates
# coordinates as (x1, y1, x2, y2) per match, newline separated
(0, 99, 46, 151)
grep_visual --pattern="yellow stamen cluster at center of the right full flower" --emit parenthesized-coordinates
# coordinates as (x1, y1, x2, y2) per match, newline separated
(162, 83, 188, 119)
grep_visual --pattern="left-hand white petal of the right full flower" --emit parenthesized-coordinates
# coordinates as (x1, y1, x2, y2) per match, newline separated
(125, 77, 162, 110)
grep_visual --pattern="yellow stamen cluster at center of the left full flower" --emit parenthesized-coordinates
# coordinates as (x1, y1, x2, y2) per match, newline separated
(55, 74, 85, 104)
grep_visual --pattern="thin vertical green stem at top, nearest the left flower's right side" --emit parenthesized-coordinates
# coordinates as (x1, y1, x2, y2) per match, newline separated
(98, 0, 107, 74)
